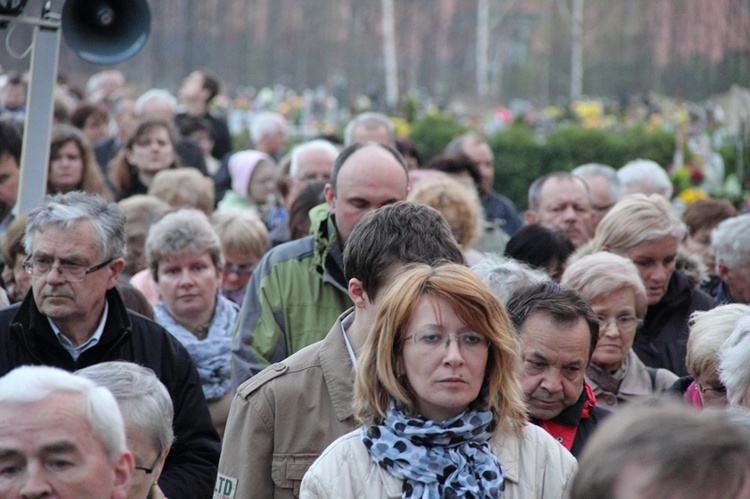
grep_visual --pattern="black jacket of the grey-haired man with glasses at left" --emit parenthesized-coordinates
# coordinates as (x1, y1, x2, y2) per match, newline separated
(0, 289, 221, 498)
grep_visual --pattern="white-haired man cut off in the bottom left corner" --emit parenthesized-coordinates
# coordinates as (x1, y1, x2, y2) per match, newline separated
(0, 366, 133, 499)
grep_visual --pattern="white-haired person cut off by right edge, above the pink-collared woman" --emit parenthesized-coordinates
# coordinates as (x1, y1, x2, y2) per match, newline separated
(711, 214, 750, 303)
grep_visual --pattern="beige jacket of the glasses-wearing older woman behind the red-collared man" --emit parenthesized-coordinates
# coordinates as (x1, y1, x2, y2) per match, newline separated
(585, 348, 677, 411)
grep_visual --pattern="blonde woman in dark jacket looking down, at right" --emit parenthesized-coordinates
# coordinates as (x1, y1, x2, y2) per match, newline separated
(590, 194, 716, 376)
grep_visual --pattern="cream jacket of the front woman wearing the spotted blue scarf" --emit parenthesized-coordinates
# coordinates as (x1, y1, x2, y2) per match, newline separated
(300, 424, 578, 499)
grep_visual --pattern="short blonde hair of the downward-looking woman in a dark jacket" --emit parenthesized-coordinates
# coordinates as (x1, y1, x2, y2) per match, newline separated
(592, 194, 686, 254)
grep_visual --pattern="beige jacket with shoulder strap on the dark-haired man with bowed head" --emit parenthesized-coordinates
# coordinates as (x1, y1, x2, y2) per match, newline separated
(214, 310, 357, 499)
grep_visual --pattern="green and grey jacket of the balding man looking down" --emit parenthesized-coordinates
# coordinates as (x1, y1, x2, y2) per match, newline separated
(232, 205, 352, 389)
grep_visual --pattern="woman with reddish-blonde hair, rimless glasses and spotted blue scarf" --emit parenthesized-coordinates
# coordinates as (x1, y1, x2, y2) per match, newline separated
(300, 264, 576, 499)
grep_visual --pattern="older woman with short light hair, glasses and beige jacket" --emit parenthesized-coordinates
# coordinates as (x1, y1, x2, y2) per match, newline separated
(560, 251, 677, 410)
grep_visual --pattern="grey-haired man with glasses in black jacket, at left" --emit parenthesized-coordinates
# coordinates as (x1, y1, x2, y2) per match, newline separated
(0, 192, 220, 497)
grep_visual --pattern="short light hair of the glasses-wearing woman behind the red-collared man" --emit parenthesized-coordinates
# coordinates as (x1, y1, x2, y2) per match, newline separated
(560, 251, 648, 319)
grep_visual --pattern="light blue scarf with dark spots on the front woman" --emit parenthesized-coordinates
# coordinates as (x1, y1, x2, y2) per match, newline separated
(362, 402, 505, 499)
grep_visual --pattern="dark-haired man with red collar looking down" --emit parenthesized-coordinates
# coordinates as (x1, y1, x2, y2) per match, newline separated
(507, 282, 609, 457)
